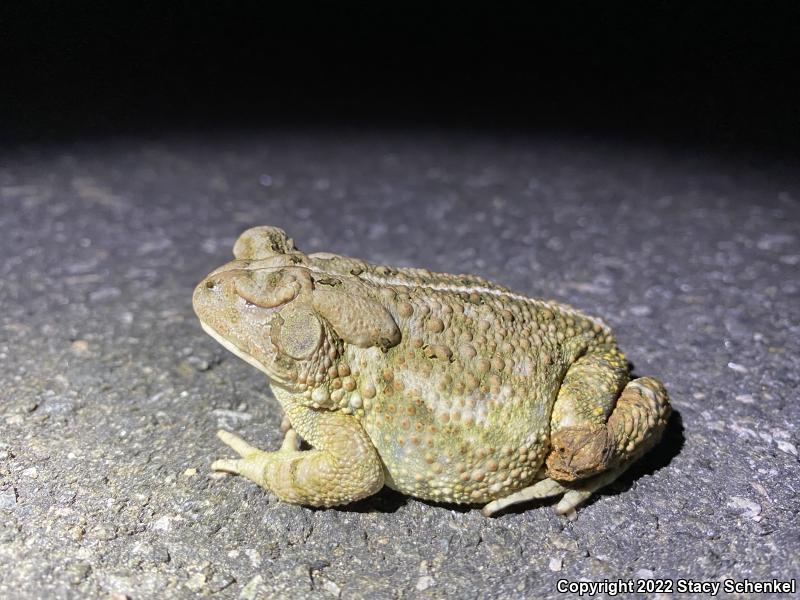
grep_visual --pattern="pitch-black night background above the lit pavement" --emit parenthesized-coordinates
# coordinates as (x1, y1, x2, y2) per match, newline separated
(0, 2, 800, 152)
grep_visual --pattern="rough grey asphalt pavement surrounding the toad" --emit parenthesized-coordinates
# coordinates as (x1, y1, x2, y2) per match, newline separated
(0, 131, 800, 599)
